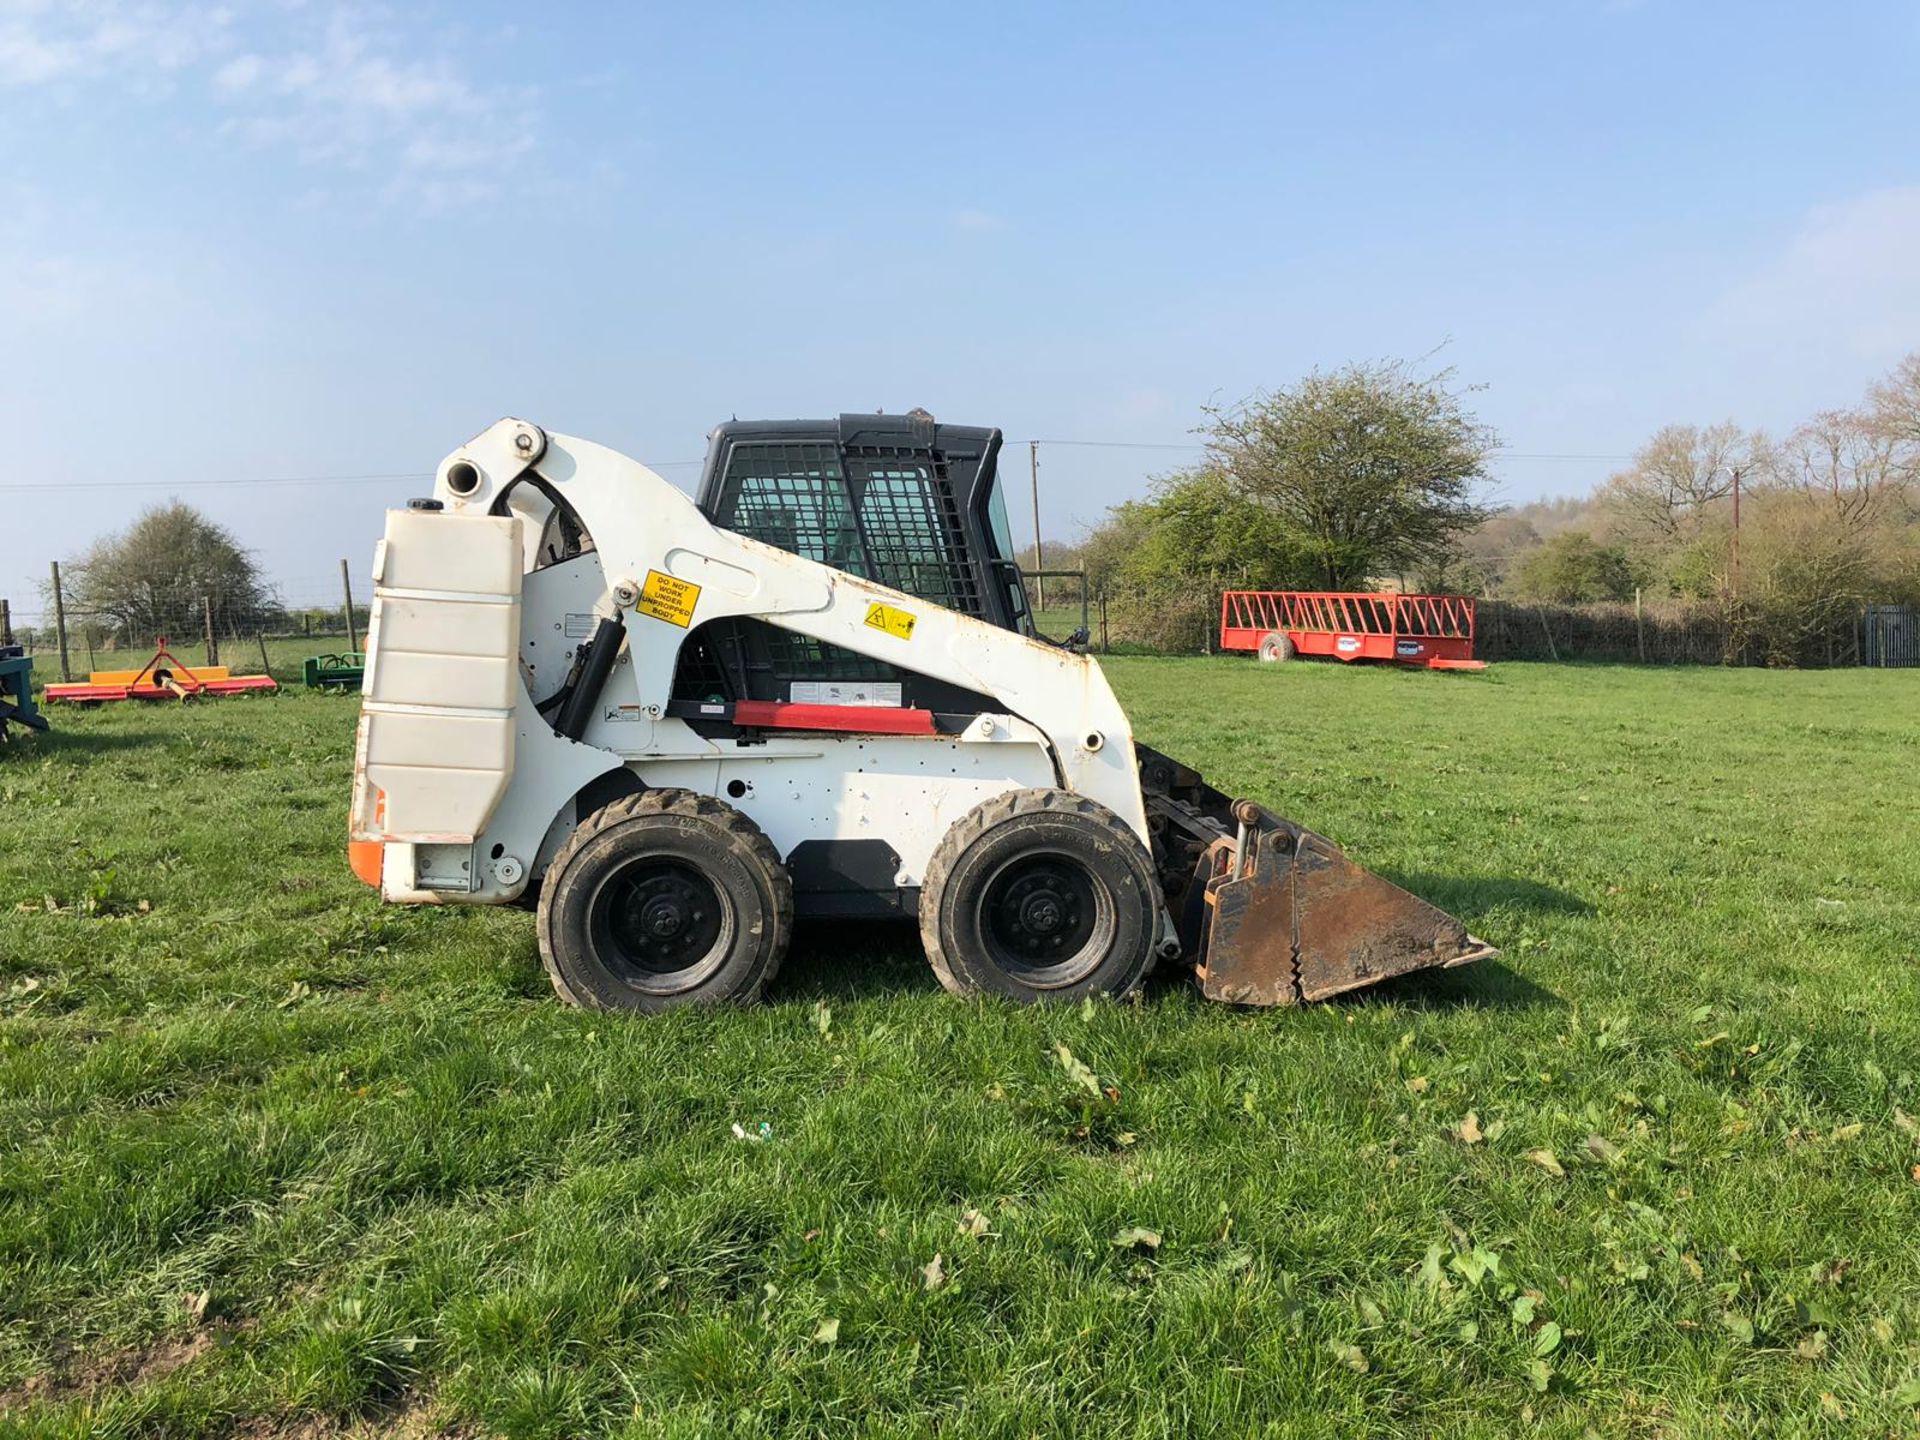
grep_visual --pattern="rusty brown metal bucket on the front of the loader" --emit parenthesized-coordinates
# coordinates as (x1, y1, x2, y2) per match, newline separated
(1190, 801, 1498, 1004)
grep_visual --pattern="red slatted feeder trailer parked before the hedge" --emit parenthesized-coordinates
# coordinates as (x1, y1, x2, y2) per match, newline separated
(1219, 589, 1486, 670)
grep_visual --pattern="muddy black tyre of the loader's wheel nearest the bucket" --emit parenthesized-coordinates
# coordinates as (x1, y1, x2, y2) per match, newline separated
(920, 789, 1160, 1004)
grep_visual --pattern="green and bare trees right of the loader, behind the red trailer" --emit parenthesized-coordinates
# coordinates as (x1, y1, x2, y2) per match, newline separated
(1056, 353, 1920, 664)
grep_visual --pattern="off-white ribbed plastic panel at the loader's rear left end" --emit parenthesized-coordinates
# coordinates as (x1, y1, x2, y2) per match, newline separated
(353, 511, 522, 843)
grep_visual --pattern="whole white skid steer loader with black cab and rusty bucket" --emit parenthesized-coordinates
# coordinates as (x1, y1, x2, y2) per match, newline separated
(349, 411, 1492, 1010)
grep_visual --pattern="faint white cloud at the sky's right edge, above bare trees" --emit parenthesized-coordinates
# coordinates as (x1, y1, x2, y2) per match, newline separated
(1707, 184, 1920, 369)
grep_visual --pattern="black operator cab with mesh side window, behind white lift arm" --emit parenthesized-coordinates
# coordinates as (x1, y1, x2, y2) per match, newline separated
(674, 409, 1033, 712)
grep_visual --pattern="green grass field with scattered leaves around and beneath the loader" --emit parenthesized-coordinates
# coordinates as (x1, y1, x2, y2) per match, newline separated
(0, 659, 1920, 1438)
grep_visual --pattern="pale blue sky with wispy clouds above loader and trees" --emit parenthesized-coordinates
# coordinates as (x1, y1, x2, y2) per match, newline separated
(0, 0, 1920, 611)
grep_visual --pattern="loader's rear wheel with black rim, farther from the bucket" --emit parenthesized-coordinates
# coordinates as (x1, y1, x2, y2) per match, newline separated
(540, 789, 793, 1012)
